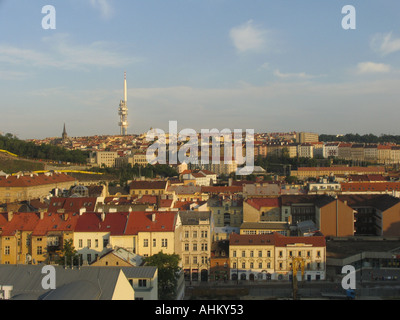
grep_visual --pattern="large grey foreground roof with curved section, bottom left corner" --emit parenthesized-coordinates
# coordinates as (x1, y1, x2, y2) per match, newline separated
(0, 265, 140, 300)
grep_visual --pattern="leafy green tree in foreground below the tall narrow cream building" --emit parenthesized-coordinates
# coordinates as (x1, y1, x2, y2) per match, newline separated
(144, 251, 181, 300)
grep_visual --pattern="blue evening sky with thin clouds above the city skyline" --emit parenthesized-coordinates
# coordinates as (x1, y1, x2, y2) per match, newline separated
(0, 0, 400, 139)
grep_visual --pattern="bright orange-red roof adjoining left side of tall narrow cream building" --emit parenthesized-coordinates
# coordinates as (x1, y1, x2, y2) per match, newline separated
(125, 211, 177, 235)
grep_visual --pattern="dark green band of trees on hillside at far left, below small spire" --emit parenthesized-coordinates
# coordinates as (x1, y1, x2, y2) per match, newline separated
(0, 133, 89, 163)
